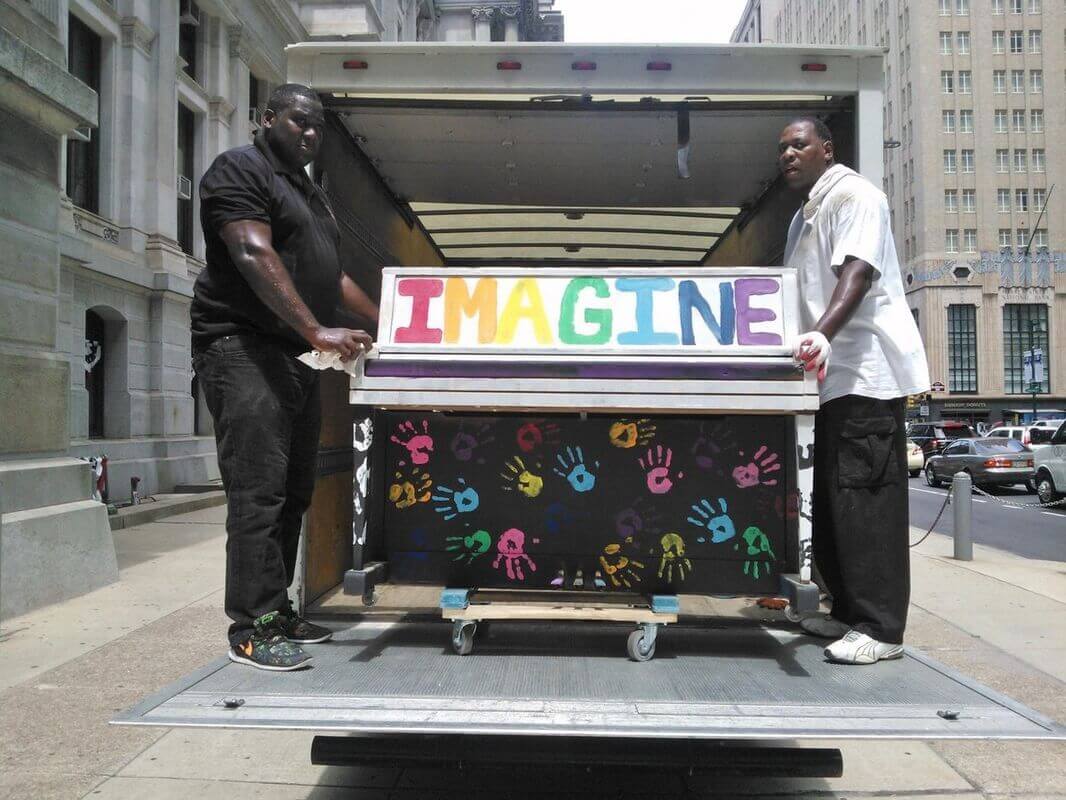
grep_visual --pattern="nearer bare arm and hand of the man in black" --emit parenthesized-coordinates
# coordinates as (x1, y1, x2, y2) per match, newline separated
(221, 220, 373, 358)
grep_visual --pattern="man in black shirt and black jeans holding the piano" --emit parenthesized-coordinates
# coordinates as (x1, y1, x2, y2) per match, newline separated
(192, 83, 377, 670)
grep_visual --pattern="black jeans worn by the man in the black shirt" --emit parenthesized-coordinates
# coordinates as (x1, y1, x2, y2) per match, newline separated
(193, 335, 321, 644)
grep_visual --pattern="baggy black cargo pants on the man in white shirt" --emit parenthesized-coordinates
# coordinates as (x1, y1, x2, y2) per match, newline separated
(811, 395, 910, 643)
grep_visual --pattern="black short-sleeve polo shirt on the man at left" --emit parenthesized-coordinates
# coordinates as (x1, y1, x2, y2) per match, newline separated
(191, 134, 340, 350)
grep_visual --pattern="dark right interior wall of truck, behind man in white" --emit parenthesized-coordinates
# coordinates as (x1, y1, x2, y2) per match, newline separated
(693, 111, 855, 267)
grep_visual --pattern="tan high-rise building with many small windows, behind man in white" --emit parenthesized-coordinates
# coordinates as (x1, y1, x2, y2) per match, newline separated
(733, 0, 1066, 423)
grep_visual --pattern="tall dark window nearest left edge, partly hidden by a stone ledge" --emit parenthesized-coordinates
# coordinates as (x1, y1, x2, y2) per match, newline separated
(66, 14, 101, 213)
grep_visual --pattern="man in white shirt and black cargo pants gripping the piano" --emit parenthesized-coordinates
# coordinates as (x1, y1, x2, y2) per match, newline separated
(778, 117, 930, 663)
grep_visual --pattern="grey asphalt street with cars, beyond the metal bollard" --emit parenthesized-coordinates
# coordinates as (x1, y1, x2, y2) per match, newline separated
(909, 477, 1066, 561)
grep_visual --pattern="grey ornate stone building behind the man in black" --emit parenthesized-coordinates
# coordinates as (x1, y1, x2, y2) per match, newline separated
(0, 0, 562, 617)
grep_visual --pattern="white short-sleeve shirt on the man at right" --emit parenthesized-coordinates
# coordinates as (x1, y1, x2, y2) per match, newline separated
(785, 164, 930, 403)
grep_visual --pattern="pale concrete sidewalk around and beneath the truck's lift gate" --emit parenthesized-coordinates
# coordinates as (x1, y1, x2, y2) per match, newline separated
(0, 508, 1066, 800)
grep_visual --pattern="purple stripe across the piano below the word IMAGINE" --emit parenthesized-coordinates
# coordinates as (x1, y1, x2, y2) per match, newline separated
(364, 358, 803, 381)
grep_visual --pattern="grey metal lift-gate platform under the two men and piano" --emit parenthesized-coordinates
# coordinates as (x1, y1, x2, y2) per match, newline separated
(114, 622, 1066, 739)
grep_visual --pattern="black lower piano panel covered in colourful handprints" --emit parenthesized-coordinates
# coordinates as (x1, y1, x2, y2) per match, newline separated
(376, 412, 794, 594)
